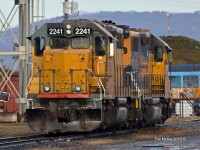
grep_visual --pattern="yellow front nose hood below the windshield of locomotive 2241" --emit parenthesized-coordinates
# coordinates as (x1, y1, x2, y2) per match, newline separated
(43, 49, 91, 93)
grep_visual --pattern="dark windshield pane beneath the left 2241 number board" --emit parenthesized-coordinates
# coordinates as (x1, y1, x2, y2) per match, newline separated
(50, 37, 69, 49)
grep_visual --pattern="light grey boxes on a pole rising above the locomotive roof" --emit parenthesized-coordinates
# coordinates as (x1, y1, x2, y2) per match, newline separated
(63, 0, 78, 20)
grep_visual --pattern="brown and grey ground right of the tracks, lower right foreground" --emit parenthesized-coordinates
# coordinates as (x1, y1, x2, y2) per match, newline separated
(81, 116, 200, 149)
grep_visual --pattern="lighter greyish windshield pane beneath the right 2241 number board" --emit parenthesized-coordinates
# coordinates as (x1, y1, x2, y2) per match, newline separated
(72, 37, 90, 49)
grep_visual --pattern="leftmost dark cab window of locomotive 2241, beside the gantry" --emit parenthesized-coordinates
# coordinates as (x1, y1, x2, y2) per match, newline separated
(35, 37, 45, 56)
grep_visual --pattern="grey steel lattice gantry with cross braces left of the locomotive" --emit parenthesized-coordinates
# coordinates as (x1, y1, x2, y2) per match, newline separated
(0, 0, 45, 121)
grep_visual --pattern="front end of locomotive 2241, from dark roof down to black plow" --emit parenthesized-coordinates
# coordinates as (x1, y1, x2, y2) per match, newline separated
(27, 20, 117, 131)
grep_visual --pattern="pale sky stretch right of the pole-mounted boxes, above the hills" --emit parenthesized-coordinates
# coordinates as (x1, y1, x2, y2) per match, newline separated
(77, 0, 200, 12)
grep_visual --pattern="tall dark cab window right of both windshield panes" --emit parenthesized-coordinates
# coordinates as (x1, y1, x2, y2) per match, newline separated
(95, 36, 106, 56)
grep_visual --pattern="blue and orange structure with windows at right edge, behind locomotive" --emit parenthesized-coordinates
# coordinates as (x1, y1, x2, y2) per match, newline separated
(169, 64, 200, 117)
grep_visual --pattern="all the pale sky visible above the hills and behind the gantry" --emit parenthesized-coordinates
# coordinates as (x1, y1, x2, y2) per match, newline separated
(0, 0, 200, 27)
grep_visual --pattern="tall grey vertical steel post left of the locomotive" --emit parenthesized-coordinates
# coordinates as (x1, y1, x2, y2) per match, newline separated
(15, 0, 30, 121)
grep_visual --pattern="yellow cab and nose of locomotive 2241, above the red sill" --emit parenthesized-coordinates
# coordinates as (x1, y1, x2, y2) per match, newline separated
(30, 20, 115, 94)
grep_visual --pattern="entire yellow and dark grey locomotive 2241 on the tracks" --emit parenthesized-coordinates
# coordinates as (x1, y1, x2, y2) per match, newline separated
(27, 19, 172, 132)
